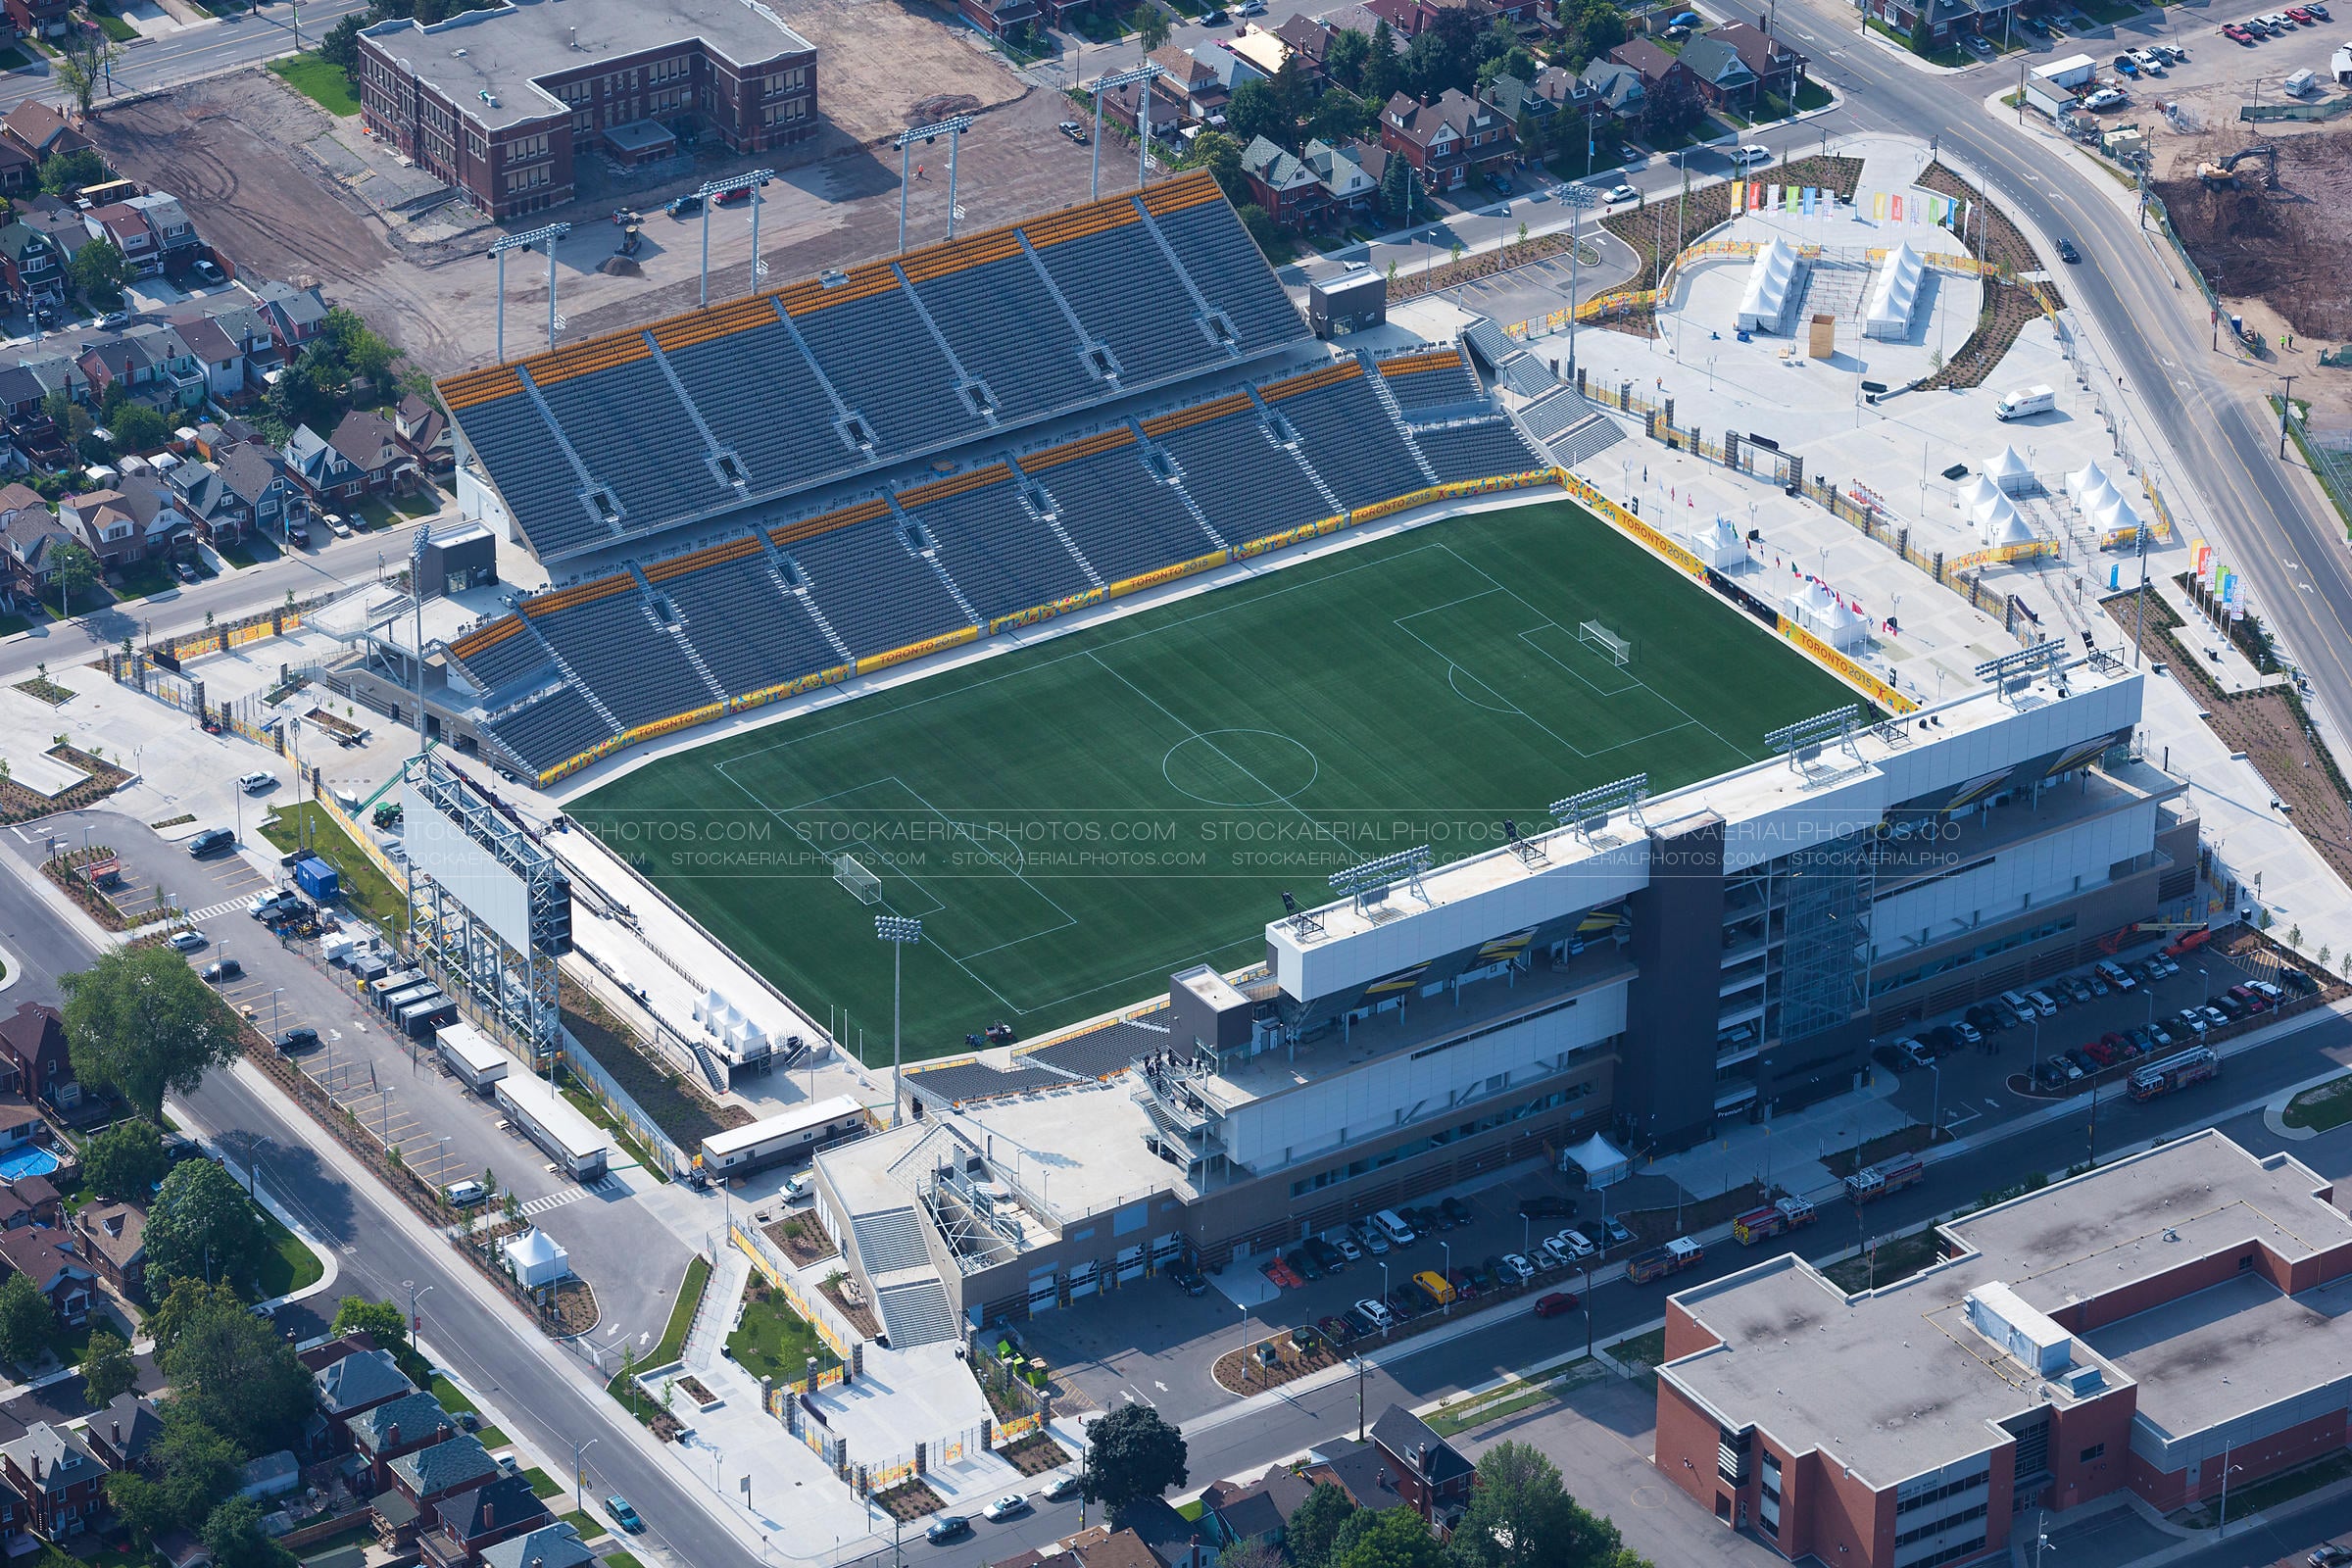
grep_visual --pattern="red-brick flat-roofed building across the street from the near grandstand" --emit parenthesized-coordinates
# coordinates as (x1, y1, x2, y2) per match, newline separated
(1656, 1131, 2352, 1568)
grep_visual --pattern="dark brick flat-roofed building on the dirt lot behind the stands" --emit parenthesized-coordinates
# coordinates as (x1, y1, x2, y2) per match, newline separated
(360, 0, 816, 220)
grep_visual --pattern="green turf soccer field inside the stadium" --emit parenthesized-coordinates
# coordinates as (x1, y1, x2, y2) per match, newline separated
(571, 501, 1853, 1060)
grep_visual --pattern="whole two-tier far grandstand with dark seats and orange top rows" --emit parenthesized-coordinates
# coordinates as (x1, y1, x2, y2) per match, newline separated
(435, 174, 1547, 783)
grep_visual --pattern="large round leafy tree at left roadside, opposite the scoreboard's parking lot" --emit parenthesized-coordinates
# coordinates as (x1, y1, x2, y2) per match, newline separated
(59, 945, 242, 1128)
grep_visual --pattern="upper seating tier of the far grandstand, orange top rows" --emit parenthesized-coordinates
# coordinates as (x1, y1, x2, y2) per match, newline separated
(440, 172, 1305, 562)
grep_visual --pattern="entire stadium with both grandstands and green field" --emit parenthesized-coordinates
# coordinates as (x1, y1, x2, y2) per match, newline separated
(386, 176, 2194, 1345)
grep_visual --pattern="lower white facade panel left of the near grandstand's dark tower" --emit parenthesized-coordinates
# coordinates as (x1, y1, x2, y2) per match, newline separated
(1225, 978, 1630, 1171)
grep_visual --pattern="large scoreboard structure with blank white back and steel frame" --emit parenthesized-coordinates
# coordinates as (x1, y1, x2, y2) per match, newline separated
(400, 753, 571, 1060)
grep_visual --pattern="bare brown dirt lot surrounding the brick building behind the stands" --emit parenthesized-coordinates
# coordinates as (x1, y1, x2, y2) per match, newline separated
(92, 0, 1101, 373)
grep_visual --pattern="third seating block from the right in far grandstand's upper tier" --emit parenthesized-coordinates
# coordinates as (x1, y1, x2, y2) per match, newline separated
(901, 228, 1107, 418)
